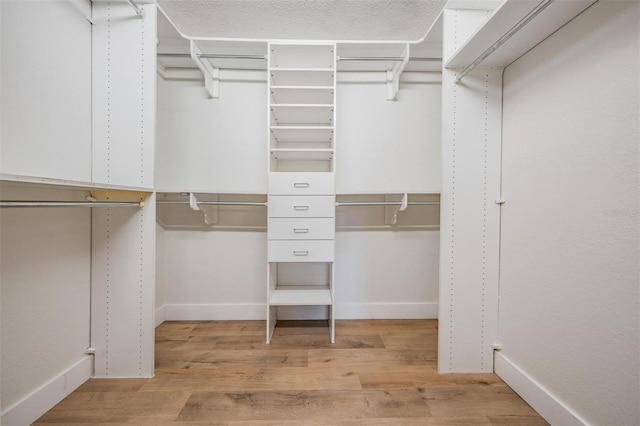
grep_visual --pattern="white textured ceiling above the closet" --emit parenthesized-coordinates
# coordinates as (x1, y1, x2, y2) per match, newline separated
(157, 0, 446, 41)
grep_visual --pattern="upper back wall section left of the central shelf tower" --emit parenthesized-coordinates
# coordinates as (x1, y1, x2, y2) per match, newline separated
(156, 77, 267, 194)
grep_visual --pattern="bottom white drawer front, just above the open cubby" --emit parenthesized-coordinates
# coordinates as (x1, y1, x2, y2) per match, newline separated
(267, 240, 335, 262)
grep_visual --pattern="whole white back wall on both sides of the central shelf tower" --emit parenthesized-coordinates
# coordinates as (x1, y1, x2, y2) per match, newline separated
(156, 72, 441, 319)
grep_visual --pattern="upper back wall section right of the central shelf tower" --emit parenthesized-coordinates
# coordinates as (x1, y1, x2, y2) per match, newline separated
(336, 80, 442, 194)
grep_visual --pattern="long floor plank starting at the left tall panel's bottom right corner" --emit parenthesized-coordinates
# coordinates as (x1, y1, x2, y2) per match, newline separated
(141, 366, 361, 392)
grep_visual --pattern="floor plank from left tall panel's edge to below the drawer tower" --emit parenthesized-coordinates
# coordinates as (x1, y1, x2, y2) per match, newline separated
(155, 349, 308, 368)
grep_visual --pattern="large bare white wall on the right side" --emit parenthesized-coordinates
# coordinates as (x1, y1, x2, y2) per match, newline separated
(497, 0, 640, 425)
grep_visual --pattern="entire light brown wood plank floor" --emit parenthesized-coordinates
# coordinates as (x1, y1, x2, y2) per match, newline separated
(36, 320, 547, 426)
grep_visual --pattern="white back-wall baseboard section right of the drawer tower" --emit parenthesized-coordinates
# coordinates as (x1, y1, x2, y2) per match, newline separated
(335, 302, 438, 319)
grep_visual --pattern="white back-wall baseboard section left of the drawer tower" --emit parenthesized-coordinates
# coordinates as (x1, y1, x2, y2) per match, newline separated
(164, 303, 267, 321)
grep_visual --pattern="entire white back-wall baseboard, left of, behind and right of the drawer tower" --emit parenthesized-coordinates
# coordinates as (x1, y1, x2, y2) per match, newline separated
(162, 303, 438, 326)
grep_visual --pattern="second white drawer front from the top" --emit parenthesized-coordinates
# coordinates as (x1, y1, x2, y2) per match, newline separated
(267, 195, 336, 217)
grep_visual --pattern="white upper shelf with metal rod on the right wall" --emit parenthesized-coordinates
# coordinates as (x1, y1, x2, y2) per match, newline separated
(445, 0, 595, 68)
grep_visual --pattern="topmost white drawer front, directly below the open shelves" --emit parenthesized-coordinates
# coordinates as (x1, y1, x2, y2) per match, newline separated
(269, 173, 335, 195)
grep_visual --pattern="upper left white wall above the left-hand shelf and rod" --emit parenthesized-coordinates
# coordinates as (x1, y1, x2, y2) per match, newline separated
(0, 0, 91, 182)
